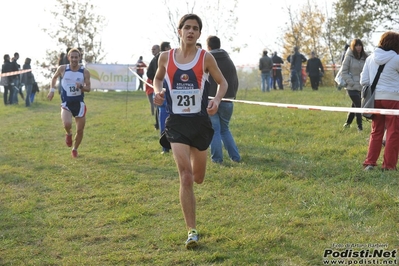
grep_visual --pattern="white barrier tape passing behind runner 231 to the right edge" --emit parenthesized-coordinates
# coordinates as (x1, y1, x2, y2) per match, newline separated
(129, 68, 399, 115)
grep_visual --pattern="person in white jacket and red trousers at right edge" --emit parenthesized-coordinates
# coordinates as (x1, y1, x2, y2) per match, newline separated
(360, 31, 399, 170)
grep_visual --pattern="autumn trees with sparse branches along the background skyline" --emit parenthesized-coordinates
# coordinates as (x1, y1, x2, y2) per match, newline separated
(39, 0, 399, 89)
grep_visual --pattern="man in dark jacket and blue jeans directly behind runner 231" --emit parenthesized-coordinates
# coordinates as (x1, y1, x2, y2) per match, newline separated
(205, 35, 241, 163)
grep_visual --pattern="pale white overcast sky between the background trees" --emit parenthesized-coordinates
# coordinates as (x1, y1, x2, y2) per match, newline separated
(0, 0, 340, 68)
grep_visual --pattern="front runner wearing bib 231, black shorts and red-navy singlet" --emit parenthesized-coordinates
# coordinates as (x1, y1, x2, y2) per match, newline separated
(154, 14, 228, 248)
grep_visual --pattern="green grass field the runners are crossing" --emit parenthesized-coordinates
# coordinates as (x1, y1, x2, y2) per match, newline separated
(0, 87, 399, 266)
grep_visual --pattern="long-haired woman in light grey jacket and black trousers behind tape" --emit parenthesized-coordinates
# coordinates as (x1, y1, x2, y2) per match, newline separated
(342, 39, 368, 132)
